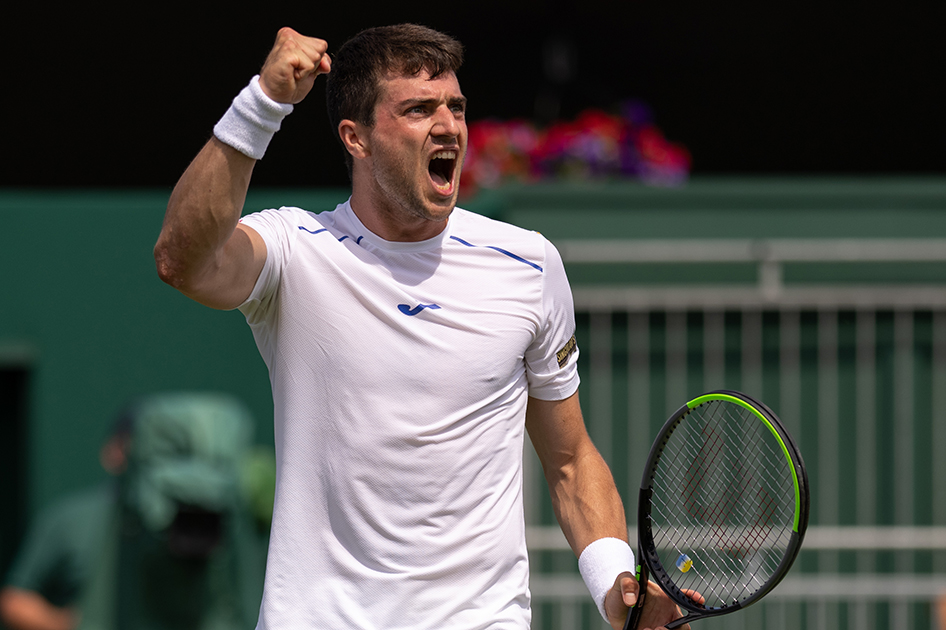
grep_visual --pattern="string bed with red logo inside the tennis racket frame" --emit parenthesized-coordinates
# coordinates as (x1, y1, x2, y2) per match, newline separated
(651, 401, 794, 607)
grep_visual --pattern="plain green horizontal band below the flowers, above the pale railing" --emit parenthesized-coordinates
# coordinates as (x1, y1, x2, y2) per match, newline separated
(484, 177, 946, 241)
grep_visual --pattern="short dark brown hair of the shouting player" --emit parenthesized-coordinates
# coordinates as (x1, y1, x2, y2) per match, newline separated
(325, 24, 463, 177)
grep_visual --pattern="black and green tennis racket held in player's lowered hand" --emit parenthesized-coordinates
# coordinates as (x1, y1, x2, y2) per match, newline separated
(624, 390, 809, 630)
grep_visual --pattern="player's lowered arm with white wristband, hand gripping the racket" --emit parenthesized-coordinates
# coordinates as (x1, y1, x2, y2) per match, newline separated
(526, 393, 688, 630)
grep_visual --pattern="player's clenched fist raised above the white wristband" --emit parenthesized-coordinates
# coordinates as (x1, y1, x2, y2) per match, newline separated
(260, 27, 332, 105)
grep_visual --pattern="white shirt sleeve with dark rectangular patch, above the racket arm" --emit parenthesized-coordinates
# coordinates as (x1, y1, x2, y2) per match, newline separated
(525, 237, 579, 400)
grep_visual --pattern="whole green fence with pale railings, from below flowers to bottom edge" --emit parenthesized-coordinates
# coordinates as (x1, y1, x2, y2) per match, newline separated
(510, 182, 946, 629)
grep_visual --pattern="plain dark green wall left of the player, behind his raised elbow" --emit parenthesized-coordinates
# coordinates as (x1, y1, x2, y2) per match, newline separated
(0, 191, 347, 511)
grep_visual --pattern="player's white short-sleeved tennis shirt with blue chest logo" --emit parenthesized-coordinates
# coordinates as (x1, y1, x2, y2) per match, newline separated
(240, 203, 578, 630)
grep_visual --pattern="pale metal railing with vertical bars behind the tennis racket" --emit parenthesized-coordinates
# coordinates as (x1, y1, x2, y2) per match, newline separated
(526, 239, 946, 630)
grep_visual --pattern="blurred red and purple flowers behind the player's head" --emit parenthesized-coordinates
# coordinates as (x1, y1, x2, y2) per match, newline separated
(461, 101, 691, 194)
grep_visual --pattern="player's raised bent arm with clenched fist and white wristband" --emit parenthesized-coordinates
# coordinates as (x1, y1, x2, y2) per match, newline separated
(154, 28, 331, 309)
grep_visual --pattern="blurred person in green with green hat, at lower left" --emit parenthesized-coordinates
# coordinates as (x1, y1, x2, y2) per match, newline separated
(0, 393, 272, 630)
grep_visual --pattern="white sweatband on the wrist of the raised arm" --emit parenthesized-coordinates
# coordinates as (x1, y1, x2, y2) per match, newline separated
(214, 75, 292, 160)
